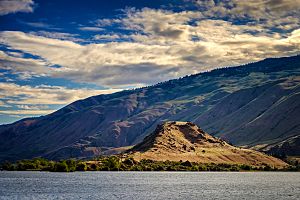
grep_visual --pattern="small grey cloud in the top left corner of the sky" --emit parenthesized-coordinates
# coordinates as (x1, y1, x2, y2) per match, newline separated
(0, 0, 34, 15)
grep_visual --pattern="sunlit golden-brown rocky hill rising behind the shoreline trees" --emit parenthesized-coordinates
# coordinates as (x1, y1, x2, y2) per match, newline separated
(130, 122, 287, 168)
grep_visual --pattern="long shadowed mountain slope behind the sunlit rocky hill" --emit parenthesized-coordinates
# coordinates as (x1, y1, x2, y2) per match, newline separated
(0, 56, 300, 161)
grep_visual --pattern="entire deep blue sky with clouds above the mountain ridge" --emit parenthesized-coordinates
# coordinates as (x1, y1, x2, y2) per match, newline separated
(0, 0, 300, 124)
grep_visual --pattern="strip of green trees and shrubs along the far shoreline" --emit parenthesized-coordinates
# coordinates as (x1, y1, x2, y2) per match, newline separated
(0, 156, 300, 172)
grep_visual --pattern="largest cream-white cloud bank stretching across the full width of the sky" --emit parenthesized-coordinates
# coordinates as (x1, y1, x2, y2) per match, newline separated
(0, 7, 300, 88)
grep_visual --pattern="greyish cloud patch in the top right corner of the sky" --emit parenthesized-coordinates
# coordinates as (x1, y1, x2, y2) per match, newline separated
(192, 0, 300, 30)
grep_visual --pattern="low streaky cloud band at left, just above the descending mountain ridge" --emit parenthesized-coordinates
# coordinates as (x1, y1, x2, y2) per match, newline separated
(0, 83, 120, 116)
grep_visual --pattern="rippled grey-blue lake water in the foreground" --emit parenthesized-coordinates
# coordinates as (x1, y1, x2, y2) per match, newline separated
(0, 172, 300, 200)
